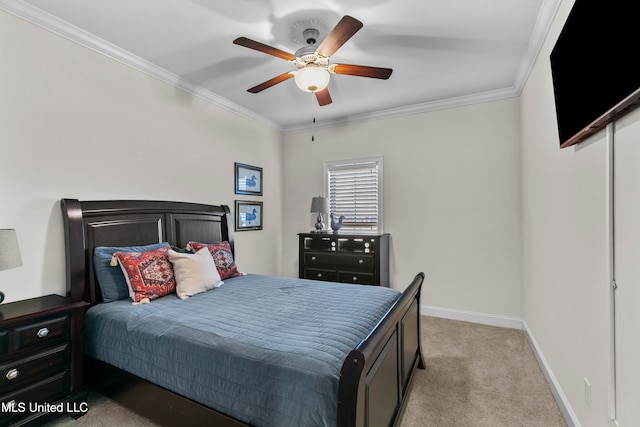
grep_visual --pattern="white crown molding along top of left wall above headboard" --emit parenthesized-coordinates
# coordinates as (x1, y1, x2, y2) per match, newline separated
(0, 0, 283, 133)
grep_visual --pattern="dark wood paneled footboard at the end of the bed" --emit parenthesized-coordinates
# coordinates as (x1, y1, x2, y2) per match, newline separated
(337, 273, 424, 427)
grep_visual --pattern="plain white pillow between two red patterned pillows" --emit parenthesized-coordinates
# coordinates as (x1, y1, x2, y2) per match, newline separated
(169, 247, 222, 299)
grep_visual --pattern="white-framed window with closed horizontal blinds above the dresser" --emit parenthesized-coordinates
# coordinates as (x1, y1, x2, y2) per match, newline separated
(324, 157, 382, 232)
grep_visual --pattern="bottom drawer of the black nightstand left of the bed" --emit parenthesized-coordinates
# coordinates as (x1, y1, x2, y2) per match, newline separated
(0, 371, 69, 425)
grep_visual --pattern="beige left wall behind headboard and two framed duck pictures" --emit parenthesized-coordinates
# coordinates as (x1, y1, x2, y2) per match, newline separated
(0, 12, 282, 301)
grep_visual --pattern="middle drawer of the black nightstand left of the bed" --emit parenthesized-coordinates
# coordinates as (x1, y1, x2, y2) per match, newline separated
(0, 344, 69, 394)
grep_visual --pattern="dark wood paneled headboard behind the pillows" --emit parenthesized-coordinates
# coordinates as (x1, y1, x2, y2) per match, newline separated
(60, 199, 234, 305)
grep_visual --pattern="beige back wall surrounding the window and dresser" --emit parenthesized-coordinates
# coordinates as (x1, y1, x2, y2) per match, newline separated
(283, 99, 522, 317)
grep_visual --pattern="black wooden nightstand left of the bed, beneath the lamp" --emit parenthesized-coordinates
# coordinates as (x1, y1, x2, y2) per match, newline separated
(0, 295, 88, 426)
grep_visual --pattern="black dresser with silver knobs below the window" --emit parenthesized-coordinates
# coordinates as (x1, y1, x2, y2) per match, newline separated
(298, 233, 389, 286)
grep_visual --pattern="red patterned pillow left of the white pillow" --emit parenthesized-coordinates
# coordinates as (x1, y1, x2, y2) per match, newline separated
(114, 246, 176, 302)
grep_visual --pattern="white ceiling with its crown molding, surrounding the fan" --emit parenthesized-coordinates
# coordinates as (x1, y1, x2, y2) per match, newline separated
(0, 0, 560, 131)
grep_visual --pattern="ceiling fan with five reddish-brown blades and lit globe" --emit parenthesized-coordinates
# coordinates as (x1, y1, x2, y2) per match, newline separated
(233, 15, 393, 106)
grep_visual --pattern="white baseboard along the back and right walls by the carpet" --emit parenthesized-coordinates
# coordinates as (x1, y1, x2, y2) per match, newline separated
(420, 305, 580, 427)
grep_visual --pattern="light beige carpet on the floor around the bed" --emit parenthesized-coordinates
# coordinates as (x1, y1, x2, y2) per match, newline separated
(47, 316, 567, 427)
